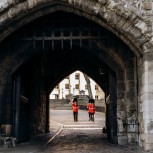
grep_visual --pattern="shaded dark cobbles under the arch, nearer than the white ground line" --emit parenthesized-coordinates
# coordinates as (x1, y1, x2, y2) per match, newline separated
(39, 129, 143, 153)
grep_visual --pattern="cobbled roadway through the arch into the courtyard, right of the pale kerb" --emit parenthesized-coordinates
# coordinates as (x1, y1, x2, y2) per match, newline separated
(38, 111, 148, 153)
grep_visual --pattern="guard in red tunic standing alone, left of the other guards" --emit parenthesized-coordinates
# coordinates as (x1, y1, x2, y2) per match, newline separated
(72, 98, 79, 122)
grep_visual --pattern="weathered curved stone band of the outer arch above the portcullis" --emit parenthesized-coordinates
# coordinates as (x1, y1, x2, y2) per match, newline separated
(0, 0, 151, 55)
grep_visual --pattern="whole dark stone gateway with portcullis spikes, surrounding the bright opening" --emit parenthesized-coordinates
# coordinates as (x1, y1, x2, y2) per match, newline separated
(0, 0, 153, 150)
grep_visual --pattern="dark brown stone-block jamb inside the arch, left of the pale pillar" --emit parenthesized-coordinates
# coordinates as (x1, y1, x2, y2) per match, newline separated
(117, 57, 138, 145)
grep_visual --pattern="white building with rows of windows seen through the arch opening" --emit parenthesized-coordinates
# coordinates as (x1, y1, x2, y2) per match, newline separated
(50, 71, 104, 100)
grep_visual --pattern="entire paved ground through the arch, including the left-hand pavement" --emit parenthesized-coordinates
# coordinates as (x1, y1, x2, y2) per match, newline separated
(0, 110, 152, 153)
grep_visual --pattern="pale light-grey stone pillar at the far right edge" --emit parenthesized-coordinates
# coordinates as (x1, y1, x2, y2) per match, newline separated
(139, 52, 153, 150)
